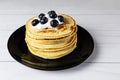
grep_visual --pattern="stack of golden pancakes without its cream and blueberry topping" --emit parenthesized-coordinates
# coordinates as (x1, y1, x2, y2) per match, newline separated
(25, 11, 77, 59)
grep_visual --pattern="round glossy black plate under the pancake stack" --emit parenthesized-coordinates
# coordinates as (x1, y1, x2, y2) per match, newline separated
(7, 26, 94, 70)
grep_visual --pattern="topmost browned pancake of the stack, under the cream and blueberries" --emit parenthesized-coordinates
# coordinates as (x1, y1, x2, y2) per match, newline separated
(26, 14, 77, 40)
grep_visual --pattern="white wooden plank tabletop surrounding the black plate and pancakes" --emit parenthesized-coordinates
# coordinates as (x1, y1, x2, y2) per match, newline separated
(0, 0, 120, 80)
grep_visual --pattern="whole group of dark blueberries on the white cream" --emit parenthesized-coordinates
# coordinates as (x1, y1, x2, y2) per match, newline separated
(32, 10, 64, 27)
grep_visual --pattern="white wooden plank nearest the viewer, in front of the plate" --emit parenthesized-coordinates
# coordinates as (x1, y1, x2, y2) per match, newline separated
(0, 62, 120, 80)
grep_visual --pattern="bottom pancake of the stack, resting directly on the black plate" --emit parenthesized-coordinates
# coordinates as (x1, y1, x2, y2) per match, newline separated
(28, 44, 76, 59)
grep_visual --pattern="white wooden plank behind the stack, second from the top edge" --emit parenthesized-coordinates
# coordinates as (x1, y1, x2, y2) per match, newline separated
(0, 14, 120, 30)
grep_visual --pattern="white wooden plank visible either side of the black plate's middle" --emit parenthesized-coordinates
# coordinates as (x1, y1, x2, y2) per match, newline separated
(0, 30, 120, 62)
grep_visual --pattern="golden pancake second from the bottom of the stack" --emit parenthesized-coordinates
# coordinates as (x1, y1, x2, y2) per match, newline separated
(26, 36, 77, 51)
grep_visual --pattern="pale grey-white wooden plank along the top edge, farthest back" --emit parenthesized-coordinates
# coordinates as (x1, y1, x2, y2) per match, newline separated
(0, 0, 120, 14)
